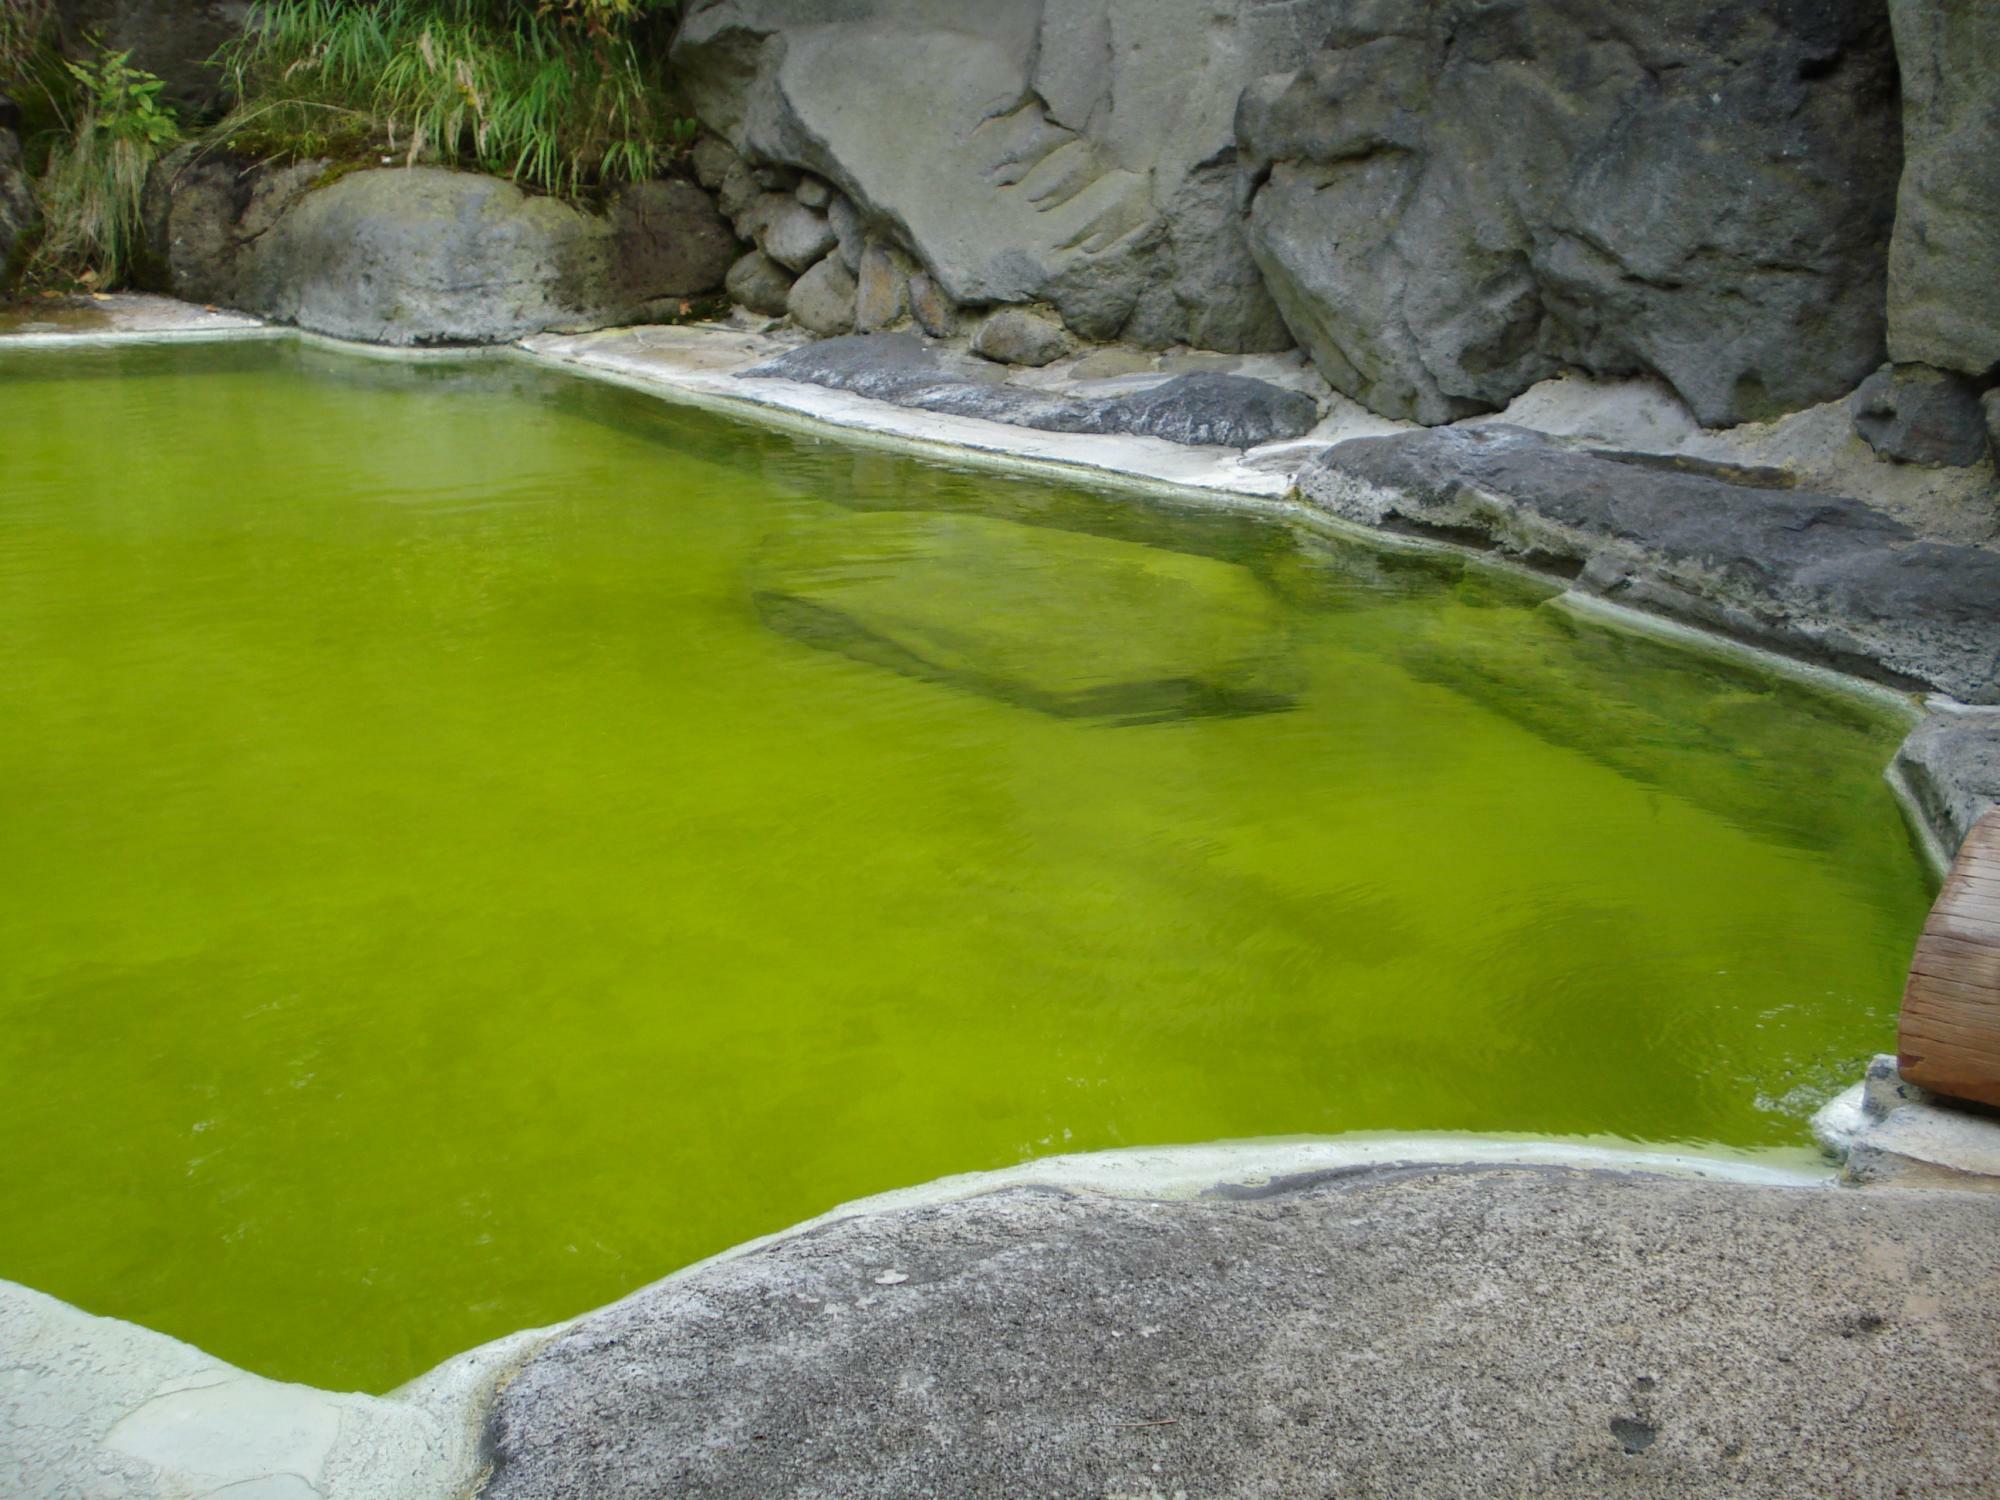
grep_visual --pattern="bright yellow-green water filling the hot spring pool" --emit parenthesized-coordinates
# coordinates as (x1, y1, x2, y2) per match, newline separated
(0, 344, 1926, 1388)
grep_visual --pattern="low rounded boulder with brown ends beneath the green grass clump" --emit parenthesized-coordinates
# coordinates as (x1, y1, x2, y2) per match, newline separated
(146, 163, 736, 344)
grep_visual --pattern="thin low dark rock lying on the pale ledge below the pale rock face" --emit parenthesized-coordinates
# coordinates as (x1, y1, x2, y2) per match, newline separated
(742, 334, 1320, 448)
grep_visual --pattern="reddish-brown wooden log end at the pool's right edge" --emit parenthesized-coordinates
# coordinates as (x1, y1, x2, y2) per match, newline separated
(1896, 808, 2000, 1106)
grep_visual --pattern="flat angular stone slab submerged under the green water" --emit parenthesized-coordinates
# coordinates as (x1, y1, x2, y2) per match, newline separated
(754, 512, 1294, 722)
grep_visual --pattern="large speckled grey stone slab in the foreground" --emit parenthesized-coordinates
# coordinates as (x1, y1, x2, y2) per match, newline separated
(484, 1168, 2000, 1500)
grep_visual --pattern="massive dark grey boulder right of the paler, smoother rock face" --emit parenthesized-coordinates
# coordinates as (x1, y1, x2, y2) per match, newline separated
(1238, 0, 1904, 426)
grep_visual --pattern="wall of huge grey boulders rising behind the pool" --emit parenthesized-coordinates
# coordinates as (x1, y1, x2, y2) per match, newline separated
(674, 0, 2000, 462)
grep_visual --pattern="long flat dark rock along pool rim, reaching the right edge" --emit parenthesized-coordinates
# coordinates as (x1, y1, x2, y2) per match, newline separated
(1298, 426, 2000, 704)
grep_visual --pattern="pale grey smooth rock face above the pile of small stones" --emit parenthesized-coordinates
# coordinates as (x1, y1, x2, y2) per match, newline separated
(674, 0, 1326, 350)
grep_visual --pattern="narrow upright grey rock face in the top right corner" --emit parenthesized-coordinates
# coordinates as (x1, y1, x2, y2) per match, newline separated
(1888, 0, 2000, 376)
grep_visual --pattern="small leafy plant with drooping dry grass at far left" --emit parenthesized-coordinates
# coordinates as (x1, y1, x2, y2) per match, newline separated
(28, 52, 180, 286)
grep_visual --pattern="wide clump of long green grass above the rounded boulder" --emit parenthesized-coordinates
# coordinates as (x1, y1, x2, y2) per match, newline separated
(220, 0, 686, 196)
